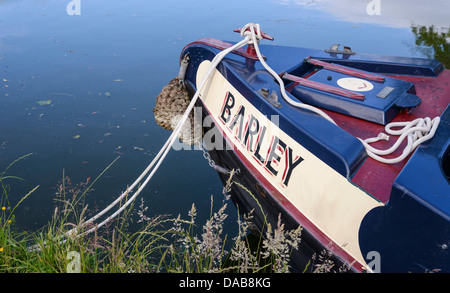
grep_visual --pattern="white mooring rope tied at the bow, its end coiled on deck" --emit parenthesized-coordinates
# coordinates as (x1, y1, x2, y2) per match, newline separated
(29, 23, 440, 250)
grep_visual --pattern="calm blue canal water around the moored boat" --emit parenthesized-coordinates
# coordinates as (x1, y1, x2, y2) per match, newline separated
(0, 0, 450, 234)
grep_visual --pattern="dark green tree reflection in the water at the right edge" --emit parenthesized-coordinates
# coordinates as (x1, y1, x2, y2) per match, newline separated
(412, 25, 450, 68)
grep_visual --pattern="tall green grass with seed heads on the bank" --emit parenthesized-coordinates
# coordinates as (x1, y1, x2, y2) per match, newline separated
(0, 155, 312, 273)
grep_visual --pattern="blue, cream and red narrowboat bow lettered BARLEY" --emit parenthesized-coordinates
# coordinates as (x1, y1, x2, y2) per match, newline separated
(167, 24, 450, 272)
